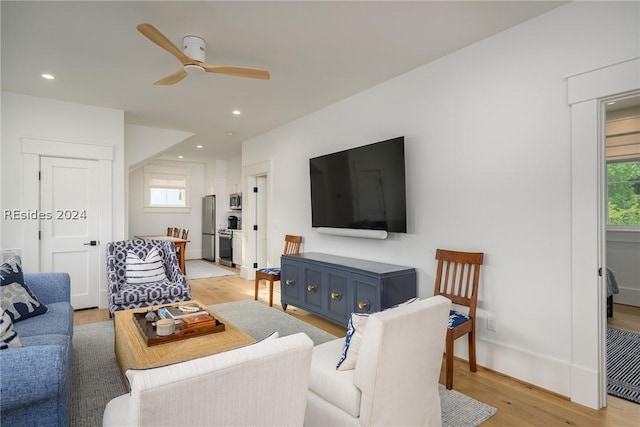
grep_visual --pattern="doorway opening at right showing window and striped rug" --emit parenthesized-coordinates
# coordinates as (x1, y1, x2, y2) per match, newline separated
(603, 93, 640, 404)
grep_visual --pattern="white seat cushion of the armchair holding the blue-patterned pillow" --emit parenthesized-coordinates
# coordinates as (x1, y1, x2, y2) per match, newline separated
(309, 338, 361, 417)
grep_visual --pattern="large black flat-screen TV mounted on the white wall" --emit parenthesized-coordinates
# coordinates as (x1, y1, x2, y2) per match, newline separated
(309, 137, 407, 233)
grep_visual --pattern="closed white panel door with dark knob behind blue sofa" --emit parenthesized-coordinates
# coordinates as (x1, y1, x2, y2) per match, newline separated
(40, 157, 100, 309)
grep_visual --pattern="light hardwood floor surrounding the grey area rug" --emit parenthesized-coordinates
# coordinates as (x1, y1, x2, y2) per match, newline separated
(75, 269, 640, 427)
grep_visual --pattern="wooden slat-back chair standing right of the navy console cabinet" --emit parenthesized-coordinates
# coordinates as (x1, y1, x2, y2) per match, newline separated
(433, 249, 484, 390)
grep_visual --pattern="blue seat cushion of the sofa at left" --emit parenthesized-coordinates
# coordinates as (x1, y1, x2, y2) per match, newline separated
(13, 302, 73, 338)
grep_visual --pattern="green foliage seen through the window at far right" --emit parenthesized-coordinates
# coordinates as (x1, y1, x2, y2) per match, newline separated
(607, 161, 640, 225)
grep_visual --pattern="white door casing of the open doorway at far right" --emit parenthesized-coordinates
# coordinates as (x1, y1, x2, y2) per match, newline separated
(567, 58, 640, 409)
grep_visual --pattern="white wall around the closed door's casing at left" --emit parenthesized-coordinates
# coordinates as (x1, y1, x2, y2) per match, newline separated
(1, 92, 126, 271)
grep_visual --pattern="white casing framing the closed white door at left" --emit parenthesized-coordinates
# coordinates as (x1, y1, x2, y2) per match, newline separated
(20, 137, 114, 308)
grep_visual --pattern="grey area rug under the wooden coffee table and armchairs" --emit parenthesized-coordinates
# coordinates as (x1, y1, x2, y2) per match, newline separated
(69, 300, 496, 427)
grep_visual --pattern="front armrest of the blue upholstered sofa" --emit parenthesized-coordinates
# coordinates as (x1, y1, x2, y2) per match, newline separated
(0, 345, 70, 411)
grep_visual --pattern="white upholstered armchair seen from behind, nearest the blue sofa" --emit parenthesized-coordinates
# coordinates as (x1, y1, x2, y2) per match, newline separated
(103, 333, 313, 427)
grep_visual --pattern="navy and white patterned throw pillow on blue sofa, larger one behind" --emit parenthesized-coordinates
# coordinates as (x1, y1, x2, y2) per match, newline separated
(0, 256, 47, 322)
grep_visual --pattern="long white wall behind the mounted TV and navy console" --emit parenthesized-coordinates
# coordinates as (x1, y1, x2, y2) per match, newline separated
(242, 2, 640, 396)
